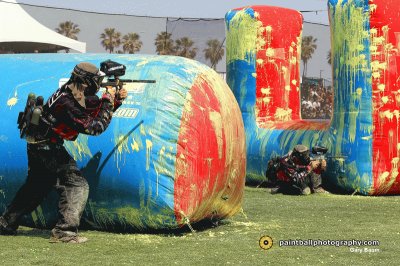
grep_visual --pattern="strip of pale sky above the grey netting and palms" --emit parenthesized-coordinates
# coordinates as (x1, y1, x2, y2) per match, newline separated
(14, 0, 328, 24)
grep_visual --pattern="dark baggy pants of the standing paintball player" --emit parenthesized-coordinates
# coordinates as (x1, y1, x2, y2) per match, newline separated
(2, 144, 89, 237)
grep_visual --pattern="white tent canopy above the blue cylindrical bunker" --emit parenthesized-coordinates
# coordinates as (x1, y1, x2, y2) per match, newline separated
(0, 0, 86, 53)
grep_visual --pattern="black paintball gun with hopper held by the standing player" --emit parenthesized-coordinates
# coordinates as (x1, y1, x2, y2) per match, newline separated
(100, 60, 156, 91)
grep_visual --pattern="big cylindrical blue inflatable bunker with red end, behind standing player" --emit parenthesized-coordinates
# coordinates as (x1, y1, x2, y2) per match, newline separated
(0, 54, 246, 230)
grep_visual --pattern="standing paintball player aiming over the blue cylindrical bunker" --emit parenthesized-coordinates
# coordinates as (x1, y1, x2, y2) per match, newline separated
(0, 62, 127, 243)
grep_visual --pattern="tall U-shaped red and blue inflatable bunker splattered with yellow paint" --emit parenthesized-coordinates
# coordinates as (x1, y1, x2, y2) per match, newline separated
(226, 0, 400, 195)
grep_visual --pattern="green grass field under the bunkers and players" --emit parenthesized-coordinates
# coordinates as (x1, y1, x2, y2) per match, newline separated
(0, 188, 400, 265)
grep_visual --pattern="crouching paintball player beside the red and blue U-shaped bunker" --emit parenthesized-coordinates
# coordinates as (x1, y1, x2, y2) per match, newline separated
(266, 145, 328, 195)
